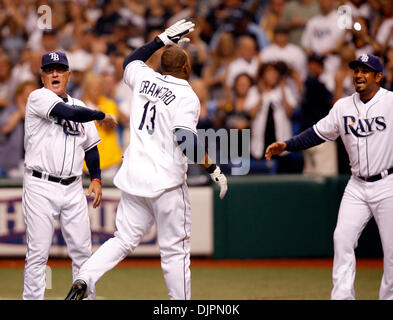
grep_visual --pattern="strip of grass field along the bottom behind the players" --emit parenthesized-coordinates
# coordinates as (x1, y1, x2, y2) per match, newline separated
(0, 267, 382, 300)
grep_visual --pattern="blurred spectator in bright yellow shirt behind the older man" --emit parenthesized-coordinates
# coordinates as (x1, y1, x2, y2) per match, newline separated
(82, 73, 122, 179)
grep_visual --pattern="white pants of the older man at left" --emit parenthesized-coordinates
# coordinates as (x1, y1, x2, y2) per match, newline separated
(22, 173, 95, 300)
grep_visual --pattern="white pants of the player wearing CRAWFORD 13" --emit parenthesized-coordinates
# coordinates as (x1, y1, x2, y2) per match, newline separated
(78, 184, 191, 300)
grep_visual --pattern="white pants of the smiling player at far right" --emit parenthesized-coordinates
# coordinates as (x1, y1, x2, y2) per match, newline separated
(331, 175, 393, 300)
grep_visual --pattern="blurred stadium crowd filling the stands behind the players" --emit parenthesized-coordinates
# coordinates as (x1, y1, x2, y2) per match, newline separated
(0, 0, 393, 183)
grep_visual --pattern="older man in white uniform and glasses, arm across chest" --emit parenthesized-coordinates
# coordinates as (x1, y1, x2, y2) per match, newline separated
(22, 52, 116, 300)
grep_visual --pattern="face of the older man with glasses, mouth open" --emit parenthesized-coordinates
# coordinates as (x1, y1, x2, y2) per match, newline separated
(41, 64, 71, 98)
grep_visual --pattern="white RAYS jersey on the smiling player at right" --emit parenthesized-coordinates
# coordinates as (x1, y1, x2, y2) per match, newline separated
(313, 88, 393, 177)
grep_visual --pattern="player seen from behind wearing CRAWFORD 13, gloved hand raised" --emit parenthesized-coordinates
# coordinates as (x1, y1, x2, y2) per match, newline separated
(66, 20, 227, 300)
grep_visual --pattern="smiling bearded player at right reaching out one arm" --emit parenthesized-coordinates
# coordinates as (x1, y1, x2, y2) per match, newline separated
(265, 54, 393, 300)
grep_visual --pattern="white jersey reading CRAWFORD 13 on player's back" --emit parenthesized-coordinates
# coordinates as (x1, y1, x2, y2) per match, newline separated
(114, 60, 200, 197)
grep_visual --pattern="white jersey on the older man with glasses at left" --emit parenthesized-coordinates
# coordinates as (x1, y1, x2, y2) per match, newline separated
(24, 88, 101, 178)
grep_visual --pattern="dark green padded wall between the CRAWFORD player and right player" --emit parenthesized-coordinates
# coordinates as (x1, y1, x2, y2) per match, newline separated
(214, 175, 381, 258)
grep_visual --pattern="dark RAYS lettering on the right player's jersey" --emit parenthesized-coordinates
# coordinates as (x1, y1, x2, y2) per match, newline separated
(343, 116, 386, 138)
